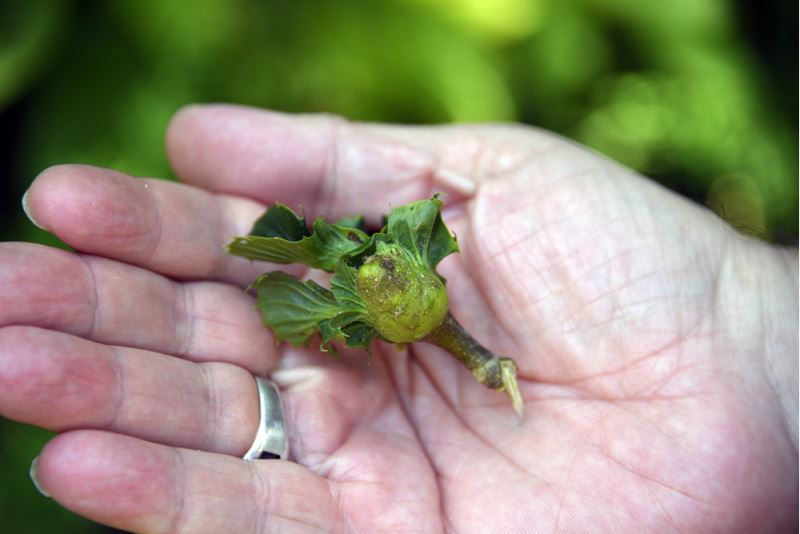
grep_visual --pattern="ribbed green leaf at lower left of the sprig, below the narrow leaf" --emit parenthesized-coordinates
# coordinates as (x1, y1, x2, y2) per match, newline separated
(253, 271, 340, 345)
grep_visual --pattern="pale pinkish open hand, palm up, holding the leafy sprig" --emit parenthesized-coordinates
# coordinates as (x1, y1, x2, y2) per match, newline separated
(0, 102, 798, 533)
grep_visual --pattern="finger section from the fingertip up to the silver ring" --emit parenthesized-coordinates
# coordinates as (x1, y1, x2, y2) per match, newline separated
(0, 326, 259, 456)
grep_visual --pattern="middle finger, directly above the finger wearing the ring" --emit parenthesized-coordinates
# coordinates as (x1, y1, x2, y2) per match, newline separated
(0, 243, 277, 374)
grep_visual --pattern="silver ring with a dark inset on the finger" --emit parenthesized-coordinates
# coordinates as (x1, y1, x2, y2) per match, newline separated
(243, 376, 289, 460)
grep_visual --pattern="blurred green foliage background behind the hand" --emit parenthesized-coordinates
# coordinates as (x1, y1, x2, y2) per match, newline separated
(0, 0, 798, 532)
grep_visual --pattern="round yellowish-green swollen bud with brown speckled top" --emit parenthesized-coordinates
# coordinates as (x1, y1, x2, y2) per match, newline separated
(356, 245, 447, 343)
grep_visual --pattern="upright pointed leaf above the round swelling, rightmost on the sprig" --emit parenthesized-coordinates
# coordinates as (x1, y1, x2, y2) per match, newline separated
(386, 195, 458, 270)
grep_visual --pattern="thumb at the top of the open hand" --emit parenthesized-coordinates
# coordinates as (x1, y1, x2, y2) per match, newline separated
(167, 105, 496, 223)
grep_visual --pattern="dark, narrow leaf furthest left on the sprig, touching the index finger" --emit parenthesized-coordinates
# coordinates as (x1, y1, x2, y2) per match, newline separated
(228, 204, 369, 272)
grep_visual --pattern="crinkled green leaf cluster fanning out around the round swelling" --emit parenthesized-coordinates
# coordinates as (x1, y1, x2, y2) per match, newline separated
(233, 196, 458, 352)
